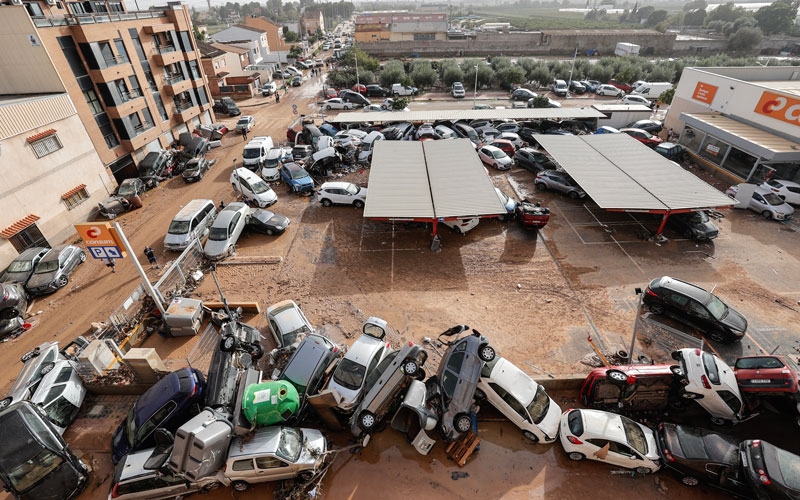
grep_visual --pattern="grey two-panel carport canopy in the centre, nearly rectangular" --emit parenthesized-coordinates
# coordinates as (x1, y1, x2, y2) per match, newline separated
(364, 139, 506, 221)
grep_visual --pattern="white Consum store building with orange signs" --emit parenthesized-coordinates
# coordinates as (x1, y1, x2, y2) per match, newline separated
(665, 66, 800, 182)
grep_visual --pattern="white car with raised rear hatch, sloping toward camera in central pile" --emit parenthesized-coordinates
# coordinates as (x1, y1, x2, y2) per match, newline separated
(328, 317, 392, 413)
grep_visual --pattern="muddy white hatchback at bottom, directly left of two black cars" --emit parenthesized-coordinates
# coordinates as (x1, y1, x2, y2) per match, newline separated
(560, 410, 661, 474)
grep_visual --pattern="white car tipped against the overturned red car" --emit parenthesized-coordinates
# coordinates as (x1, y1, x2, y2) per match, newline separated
(672, 347, 744, 425)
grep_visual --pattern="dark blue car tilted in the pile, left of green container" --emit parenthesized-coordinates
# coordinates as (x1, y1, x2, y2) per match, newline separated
(111, 368, 206, 464)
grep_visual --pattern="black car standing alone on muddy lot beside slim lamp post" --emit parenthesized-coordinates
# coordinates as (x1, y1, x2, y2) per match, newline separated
(642, 276, 747, 342)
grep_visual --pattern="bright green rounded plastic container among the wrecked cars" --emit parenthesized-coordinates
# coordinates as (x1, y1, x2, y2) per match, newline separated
(242, 380, 300, 425)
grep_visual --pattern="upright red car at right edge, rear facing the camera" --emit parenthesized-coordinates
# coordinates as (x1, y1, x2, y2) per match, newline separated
(733, 355, 800, 396)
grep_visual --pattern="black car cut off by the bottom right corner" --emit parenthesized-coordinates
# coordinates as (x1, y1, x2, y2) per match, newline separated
(739, 439, 800, 500)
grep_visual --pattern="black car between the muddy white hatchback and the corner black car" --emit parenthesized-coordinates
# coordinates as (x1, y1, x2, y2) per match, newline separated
(656, 422, 751, 498)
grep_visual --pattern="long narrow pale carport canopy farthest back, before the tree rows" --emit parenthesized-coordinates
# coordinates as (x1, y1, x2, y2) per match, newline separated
(328, 108, 605, 123)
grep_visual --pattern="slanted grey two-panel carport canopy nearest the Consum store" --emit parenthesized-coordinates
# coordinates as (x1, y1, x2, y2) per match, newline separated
(534, 134, 737, 213)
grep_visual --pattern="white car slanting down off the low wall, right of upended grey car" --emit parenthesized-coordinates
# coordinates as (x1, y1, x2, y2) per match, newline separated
(475, 356, 561, 443)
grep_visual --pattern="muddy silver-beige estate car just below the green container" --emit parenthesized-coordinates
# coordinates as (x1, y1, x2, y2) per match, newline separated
(220, 426, 328, 491)
